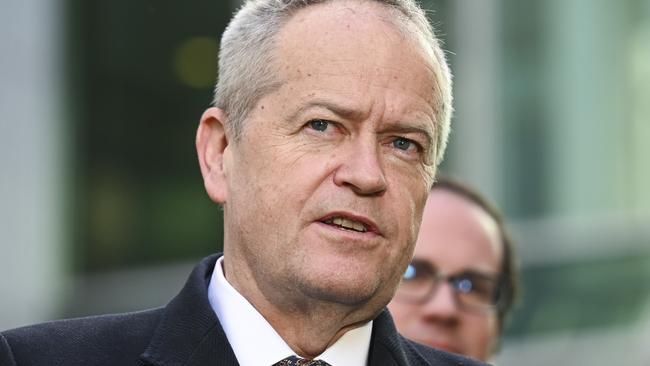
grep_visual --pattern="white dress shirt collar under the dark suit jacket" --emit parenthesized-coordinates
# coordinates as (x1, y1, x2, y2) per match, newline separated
(208, 257, 372, 366)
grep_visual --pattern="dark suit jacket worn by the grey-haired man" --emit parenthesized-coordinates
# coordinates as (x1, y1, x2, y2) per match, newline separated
(0, 255, 479, 366)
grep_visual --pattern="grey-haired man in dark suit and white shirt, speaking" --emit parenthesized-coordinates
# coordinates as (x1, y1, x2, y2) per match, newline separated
(0, 0, 486, 366)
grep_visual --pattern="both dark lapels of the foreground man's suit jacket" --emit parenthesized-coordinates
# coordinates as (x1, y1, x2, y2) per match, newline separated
(140, 254, 454, 366)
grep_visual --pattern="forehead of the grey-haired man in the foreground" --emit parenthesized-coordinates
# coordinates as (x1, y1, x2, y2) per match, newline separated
(274, 1, 435, 106)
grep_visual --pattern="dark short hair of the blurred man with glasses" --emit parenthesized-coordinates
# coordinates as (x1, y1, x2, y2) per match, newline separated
(431, 175, 519, 331)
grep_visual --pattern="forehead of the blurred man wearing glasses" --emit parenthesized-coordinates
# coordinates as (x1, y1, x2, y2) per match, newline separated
(415, 189, 503, 273)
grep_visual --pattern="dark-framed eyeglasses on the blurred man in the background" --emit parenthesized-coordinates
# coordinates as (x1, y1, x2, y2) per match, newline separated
(395, 259, 506, 313)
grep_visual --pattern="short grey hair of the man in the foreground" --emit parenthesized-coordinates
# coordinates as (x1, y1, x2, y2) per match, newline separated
(213, 0, 452, 165)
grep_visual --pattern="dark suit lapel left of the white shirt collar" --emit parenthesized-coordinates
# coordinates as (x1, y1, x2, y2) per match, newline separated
(140, 254, 239, 366)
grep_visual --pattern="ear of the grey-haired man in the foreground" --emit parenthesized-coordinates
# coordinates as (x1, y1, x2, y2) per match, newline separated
(196, 107, 229, 204)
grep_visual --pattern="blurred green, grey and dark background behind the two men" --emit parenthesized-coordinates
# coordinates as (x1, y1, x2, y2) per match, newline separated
(0, 0, 650, 366)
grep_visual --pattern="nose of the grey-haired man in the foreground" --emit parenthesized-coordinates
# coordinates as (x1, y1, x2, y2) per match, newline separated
(334, 140, 387, 196)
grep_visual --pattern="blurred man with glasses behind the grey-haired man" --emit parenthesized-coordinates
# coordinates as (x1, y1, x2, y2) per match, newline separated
(389, 178, 516, 361)
